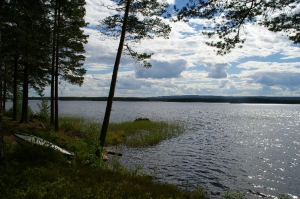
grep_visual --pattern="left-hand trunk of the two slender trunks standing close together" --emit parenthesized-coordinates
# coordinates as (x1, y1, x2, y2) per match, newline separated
(50, 1, 58, 125)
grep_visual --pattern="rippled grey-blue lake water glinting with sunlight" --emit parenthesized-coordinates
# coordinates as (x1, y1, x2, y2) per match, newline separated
(11, 101, 300, 198)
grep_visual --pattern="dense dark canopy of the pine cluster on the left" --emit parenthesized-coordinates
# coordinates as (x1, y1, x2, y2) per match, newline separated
(0, 0, 87, 122)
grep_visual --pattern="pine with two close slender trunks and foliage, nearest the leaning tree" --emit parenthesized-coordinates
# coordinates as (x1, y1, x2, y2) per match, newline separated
(50, 0, 88, 130)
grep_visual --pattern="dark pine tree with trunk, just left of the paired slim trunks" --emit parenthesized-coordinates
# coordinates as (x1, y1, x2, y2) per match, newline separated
(17, 0, 50, 122)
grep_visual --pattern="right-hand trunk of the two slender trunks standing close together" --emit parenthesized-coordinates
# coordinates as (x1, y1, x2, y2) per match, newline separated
(54, 5, 60, 131)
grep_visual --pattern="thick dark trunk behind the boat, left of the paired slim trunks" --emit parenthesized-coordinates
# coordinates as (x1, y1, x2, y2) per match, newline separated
(20, 53, 29, 123)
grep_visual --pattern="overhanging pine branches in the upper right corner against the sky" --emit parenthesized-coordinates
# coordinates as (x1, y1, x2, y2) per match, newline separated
(175, 0, 300, 55)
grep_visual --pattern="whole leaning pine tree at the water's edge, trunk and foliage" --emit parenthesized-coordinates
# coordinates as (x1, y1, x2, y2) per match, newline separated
(99, 0, 171, 147)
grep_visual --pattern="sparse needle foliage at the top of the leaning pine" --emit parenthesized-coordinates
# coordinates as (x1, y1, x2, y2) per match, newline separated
(99, 0, 171, 68)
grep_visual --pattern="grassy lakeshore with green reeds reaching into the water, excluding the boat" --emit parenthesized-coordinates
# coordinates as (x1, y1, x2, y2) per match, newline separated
(0, 117, 206, 198)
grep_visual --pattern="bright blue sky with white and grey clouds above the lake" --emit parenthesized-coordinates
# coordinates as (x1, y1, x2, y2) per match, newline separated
(37, 0, 300, 97)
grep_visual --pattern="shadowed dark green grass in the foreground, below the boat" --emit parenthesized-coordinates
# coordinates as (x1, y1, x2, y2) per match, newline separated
(0, 145, 204, 199)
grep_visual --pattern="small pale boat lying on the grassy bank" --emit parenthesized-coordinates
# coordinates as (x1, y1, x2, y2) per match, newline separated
(14, 133, 74, 156)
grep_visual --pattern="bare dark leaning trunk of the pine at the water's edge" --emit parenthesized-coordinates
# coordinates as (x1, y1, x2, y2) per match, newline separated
(99, 0, 131, 148)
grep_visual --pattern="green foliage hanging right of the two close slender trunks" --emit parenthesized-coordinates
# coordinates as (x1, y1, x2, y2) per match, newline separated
(52, 0, 88, 86)
